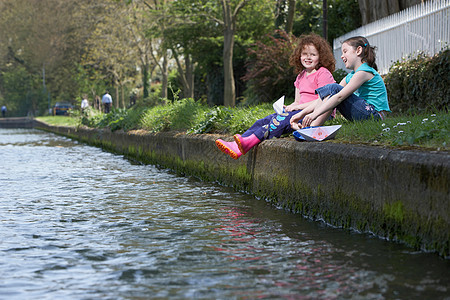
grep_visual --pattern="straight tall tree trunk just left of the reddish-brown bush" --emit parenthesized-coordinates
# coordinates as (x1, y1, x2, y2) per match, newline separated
(222, 0, 236, 107)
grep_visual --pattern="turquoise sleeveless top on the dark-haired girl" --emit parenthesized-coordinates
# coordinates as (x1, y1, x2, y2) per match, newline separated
(345, 63, 391, 111)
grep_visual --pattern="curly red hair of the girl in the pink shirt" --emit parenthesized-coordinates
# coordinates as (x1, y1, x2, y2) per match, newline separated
(289, 33, 336, 74)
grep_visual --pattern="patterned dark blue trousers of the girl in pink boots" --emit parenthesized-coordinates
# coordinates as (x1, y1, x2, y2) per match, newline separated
(242, 110, 301, 141)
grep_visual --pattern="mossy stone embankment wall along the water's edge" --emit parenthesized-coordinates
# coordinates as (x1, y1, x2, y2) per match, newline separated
(36, 123, 450, 258)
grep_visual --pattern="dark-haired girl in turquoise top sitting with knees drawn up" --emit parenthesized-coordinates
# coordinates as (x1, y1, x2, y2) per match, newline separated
(291, 36, 390, 128)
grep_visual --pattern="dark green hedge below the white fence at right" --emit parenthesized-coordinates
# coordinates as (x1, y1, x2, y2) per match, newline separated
(384, 48, 450, 114)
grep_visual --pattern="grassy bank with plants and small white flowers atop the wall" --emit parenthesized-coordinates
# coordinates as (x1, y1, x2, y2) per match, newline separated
(38, 99, 450, 151)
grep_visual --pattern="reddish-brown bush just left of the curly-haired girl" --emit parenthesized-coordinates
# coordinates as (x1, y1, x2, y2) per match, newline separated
(243, 31, 296, 103)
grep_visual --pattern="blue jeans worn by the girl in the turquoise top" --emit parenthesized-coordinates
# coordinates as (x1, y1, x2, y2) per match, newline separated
(316, 83, 382, 121)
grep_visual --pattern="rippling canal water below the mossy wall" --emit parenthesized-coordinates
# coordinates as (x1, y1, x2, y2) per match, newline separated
(0, 129, 450, 299)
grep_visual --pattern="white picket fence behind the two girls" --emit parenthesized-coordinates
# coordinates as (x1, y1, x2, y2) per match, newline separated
(333, 0, 450, 74)
